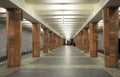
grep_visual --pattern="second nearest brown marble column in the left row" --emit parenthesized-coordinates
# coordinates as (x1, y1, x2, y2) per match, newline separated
(32, 23, 41, 57)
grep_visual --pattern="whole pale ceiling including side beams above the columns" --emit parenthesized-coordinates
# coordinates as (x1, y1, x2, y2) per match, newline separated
(0, 0, 120, 39)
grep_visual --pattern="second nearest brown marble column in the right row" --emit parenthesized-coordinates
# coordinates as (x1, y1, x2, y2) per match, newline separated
(89, 22, 98, 57)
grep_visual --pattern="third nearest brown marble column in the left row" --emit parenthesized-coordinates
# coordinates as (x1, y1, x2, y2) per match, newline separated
(43, 29, 48, 53)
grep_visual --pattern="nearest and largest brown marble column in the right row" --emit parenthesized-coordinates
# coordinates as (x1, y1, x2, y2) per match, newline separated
(103, 7, 119, 67)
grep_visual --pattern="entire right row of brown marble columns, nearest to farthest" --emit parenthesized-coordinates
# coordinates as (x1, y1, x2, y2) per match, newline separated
(74, 7, 119, 68)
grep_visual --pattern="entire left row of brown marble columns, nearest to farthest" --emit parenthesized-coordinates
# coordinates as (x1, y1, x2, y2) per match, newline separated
(6, 9, 63, 67)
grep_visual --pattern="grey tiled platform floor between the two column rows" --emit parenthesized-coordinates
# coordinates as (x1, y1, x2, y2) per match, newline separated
(0, 46, 120, 77)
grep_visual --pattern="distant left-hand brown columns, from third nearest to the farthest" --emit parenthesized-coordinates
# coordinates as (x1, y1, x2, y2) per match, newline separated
(43, 29, 63, 53)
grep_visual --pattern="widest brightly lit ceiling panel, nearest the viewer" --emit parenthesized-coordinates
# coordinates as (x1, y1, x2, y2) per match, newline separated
(34, 4, 95, 11)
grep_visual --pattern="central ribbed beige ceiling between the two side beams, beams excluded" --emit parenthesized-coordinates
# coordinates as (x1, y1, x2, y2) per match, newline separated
(25, 0, 99, 38)
